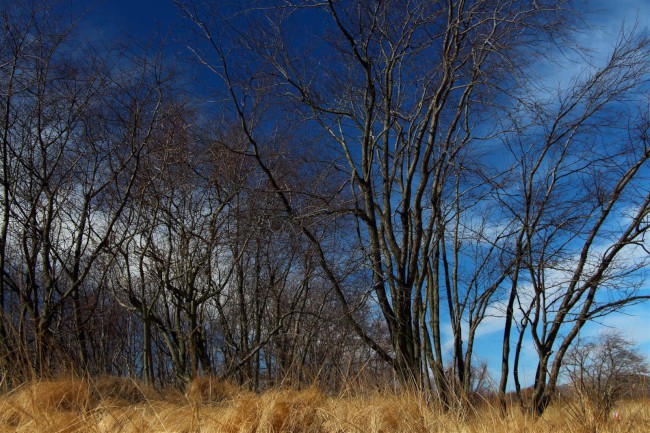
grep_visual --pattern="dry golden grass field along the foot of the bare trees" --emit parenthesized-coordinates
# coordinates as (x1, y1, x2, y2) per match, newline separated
(0, 378, 650, 433)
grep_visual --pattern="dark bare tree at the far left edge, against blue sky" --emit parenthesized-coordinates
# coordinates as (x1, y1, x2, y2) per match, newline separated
(2, 2, 170, 373)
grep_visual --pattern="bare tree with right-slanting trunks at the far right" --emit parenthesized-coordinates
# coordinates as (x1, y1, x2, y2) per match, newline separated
(494, 28, 650, 413)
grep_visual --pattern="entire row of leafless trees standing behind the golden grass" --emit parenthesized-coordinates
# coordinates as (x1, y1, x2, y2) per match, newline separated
(0, 0, 650, 414)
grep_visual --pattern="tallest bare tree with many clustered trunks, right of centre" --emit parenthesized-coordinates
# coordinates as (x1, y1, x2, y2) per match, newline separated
(178, 1, 562, 403)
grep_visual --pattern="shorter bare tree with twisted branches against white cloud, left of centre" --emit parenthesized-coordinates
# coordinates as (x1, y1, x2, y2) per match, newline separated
(115, 100, 233, 382)
